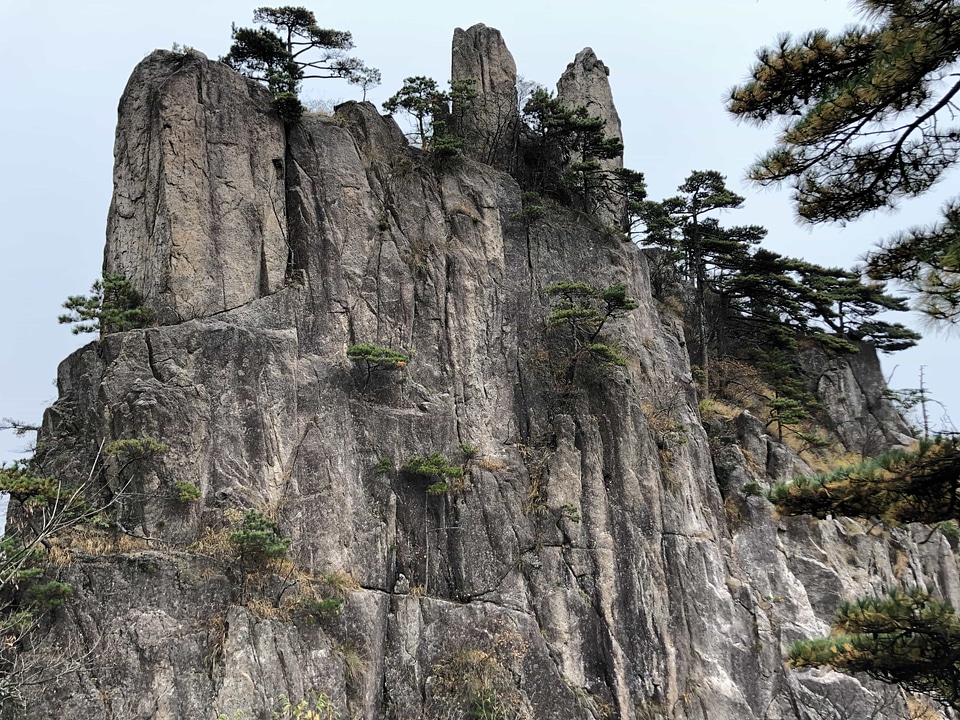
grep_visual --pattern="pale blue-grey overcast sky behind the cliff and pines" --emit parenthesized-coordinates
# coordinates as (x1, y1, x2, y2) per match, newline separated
(0, 0, 960, 461)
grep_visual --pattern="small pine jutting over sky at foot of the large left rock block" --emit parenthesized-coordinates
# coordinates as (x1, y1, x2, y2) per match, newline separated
(57, 274, 153, 335)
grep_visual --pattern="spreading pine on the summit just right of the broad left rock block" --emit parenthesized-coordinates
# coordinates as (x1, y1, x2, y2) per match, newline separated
(221, 6, 380, 122)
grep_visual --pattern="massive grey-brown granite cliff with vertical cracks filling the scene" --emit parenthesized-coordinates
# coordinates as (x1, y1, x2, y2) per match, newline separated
(11, 26, 960, 720)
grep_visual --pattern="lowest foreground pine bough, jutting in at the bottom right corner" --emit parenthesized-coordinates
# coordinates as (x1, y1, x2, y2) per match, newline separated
(789, 589, 960, 710)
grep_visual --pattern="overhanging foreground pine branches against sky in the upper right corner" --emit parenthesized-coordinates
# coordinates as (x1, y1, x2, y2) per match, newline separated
(727, 0, 960, 322)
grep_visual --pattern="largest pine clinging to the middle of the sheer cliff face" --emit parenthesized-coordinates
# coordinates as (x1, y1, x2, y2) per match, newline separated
(543, 282, 638, 388)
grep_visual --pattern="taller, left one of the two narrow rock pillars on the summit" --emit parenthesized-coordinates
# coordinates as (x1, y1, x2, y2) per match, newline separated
(450, 23, 519, 171)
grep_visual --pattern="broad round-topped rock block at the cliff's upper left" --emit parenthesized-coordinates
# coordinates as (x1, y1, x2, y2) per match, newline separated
(104, 50, 288, 323)
